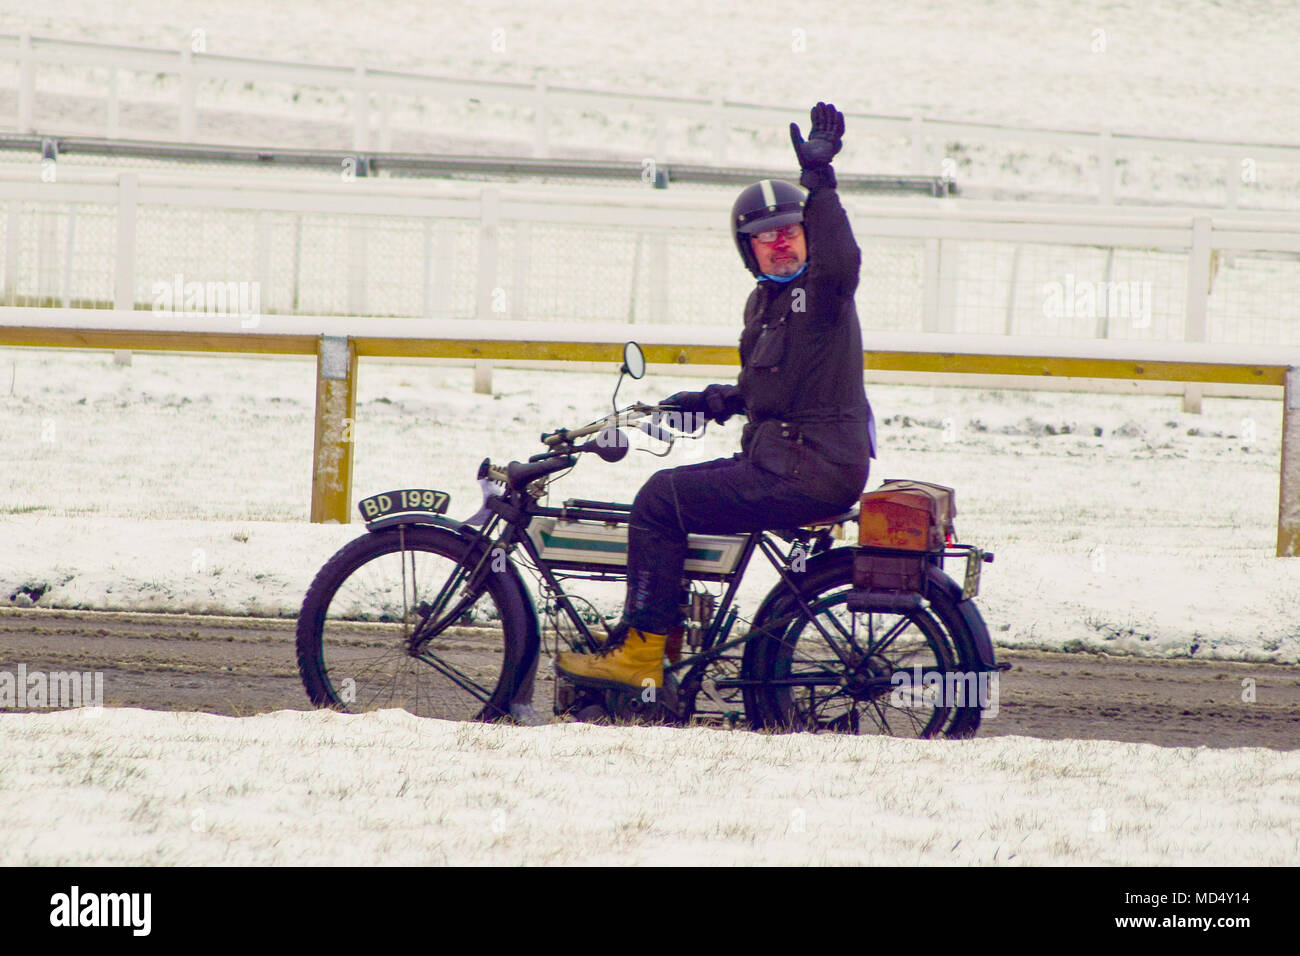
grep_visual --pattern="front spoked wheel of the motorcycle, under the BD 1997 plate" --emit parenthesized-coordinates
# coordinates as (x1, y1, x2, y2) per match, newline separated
(298, 525, 537, 721)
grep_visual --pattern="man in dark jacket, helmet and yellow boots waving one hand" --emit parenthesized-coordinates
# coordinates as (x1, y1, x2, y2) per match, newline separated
(556, 103, 875, 691)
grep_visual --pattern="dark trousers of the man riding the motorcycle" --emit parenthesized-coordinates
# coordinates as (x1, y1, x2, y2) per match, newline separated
(623, 455, 857, 633)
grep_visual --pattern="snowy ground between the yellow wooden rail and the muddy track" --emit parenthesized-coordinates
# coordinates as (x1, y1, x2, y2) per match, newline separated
(0, 350, 1300, 662)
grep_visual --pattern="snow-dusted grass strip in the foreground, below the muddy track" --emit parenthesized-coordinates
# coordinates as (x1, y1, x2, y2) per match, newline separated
(0, 709, 1300, 866)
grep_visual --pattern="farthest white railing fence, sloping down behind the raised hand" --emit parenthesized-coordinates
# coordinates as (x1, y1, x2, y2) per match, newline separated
(0, 34, 1300, 208)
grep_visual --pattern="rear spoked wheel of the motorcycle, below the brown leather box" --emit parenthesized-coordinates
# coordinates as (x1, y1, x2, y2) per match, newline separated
(745, 549, 980, 737)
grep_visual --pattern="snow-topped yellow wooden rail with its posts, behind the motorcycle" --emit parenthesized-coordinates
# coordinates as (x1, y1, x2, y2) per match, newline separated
(0, 325, 1300, 557)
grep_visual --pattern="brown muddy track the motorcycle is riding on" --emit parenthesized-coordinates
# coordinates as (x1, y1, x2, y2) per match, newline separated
(0, 609, 1300, 749)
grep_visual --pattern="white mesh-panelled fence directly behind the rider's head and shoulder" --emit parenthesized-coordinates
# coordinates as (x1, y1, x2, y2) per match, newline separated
(0, 168, 1300, 345)
